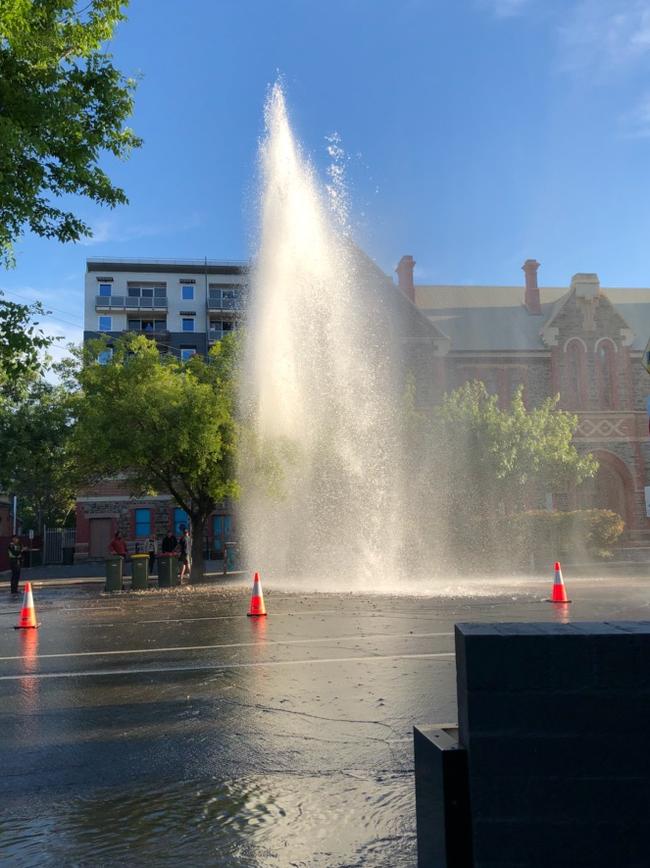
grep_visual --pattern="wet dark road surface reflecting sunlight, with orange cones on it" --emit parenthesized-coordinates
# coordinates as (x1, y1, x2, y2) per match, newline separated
(0, 576, 650, 868)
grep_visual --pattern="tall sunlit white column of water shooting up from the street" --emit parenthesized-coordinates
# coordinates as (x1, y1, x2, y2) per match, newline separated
(241, 85, 402, 587)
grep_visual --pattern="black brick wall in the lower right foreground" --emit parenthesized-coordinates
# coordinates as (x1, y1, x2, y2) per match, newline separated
(416, 622, 650, 868)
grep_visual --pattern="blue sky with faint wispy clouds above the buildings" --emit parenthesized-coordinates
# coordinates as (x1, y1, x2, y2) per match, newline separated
(6, 0, 650, 354)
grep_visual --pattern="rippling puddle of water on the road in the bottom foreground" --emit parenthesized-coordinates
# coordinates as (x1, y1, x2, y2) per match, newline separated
(0, 771, 416, 868)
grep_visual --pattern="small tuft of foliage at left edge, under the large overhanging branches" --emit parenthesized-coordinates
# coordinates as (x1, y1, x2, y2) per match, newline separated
(0, 292, 53, 396)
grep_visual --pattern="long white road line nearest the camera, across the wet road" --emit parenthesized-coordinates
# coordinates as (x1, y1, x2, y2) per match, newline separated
(0, 652, 456, 681)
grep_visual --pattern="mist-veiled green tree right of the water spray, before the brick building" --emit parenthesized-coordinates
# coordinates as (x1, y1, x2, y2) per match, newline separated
(404, 381, 598, 566)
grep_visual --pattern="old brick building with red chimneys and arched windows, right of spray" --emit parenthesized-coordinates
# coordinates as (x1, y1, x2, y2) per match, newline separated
(397, 256, 650, 540)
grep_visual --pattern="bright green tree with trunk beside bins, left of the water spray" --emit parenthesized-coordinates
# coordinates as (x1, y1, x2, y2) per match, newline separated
(75, 335, 239, 578)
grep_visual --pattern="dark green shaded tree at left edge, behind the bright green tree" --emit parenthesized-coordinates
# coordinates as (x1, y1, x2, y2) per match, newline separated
(0, 379, 75, 532)
